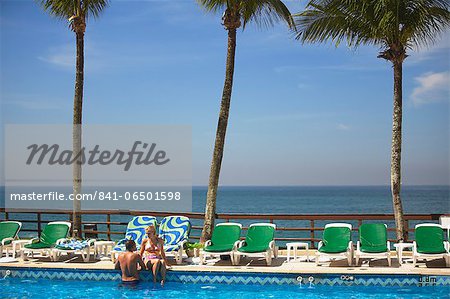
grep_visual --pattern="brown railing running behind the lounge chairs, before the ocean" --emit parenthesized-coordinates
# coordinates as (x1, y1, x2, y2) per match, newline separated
(0, 208, 448, 248)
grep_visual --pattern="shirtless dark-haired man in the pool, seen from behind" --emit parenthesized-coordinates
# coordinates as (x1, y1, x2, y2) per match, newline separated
(115, 240, 145, 282)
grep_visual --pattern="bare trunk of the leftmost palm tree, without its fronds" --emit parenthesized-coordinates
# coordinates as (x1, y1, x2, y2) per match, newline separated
(72, 32, 84, 237)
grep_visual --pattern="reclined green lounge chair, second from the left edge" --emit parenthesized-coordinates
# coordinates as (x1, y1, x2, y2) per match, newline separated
(21, 221, 71, 260)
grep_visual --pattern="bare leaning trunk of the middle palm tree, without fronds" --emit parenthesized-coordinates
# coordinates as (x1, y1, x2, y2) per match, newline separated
(201, 28, 236, 242)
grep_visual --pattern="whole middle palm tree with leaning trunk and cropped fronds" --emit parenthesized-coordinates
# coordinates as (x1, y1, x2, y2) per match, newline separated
(197, 0, 293, 241)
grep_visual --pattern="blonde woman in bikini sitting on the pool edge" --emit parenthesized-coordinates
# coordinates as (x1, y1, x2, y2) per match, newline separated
(140, 225, 170, 286)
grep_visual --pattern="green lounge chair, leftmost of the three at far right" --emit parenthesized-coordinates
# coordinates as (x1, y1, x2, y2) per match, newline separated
(316, 223, 353, 266)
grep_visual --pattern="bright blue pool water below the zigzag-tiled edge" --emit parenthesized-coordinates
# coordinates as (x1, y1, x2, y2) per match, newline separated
(0, 278, 450, 299)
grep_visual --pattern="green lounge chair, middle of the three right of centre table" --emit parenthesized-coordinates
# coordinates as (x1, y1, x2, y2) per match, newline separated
(355, 223, 391, 267)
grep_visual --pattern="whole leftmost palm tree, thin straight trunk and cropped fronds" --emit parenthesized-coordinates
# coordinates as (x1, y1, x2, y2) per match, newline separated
(37, 0, 108, 236)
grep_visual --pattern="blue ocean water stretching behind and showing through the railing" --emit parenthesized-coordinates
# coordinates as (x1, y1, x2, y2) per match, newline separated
(0, 186, 450, 239)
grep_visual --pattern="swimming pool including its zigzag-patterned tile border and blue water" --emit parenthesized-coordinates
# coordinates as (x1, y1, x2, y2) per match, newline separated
(0, 268, 450, 299)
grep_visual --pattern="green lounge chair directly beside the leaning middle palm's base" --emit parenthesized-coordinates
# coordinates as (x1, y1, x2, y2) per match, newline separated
(201, 222, 242, 264)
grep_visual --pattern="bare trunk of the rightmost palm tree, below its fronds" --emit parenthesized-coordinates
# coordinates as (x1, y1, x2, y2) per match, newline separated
(391, 61, 407, 241)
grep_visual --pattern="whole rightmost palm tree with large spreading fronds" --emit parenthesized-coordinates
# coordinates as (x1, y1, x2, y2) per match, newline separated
(294, 0, 450, 241)
